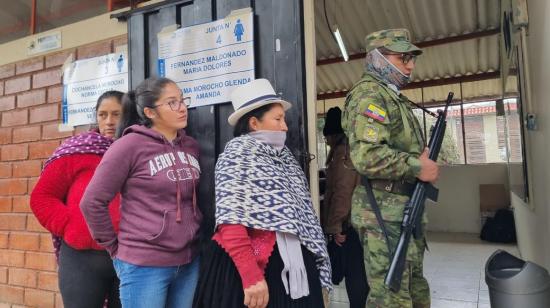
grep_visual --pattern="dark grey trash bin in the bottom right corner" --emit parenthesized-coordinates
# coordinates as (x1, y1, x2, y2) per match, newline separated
(485, 250, 550, 308)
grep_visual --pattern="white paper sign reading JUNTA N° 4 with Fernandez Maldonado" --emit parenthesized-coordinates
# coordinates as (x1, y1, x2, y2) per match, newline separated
(158, 10, 254, 107)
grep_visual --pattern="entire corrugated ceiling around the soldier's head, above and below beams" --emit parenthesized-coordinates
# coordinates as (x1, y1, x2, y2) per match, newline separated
(315, 0, 516, 100)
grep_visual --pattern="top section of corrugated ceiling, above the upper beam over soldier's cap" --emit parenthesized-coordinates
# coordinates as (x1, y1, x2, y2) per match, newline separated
(315, 0, 499, 59)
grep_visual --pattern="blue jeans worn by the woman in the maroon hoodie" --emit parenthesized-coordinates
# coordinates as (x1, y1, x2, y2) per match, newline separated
(113, 257, 199, 308)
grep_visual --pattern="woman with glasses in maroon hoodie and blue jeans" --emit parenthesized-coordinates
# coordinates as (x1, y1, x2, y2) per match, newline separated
(80, 78, 202, 308)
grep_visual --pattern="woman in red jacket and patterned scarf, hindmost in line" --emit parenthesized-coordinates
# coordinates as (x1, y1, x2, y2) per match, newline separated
(30, 91, 123, 308)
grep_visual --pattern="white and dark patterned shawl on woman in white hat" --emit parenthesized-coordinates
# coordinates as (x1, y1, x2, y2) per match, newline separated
(215, 136, 332, 290)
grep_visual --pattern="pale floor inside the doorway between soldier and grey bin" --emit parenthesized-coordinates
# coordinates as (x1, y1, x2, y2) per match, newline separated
(330, 233, 518, 308)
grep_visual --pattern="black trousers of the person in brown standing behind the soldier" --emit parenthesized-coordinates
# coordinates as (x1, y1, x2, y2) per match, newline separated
(328, 227, 370, 308)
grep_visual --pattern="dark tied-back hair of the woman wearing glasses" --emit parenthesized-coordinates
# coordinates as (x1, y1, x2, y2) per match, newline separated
(116, 77, 174, 138)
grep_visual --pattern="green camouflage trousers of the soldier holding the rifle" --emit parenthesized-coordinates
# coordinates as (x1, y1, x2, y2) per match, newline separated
(352, 189, 430, 308)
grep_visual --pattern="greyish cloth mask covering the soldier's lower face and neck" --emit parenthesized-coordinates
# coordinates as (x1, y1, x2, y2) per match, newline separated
(366, 49, 411, 89)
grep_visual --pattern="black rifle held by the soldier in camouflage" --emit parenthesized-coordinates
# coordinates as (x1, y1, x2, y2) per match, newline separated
(384, 92, 454, 292)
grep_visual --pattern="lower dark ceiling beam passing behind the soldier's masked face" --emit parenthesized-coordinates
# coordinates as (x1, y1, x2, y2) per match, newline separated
(317, 70, 516, 100)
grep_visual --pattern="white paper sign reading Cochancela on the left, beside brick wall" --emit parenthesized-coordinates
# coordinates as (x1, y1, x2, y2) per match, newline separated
(62, 52, 128, 126)
